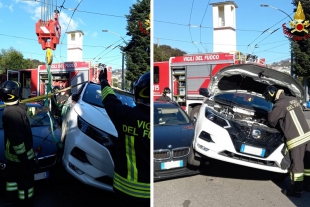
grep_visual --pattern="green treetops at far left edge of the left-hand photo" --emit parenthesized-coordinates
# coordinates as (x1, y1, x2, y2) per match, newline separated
(0, 47, 45, 74)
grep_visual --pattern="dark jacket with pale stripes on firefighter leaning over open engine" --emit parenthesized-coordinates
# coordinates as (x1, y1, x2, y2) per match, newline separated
(268, 90, 310, 150)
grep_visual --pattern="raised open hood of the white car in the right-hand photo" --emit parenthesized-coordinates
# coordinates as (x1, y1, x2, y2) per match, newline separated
(208, 64, 305, 101)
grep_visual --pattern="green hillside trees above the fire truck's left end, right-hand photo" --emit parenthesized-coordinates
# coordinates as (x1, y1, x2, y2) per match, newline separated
(154, 44, 186, 62)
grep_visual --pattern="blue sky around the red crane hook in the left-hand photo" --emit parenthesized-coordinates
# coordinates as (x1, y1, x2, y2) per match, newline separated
(0, 0, 136, 69)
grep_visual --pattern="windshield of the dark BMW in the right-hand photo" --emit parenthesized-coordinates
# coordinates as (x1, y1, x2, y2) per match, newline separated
(154, 106, 190, 125)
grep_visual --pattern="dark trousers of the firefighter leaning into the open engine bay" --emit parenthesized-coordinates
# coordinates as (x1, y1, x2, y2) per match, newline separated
(290, 142, 310, 192)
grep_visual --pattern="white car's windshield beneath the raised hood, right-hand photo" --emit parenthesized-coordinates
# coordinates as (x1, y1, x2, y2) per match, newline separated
(214, 93, 272, 111)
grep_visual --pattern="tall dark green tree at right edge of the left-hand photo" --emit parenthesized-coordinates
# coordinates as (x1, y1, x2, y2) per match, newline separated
(123, 0, 150, 82)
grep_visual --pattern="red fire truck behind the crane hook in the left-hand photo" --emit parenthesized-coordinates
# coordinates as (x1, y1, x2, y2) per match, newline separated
(7, 61, 112, 99)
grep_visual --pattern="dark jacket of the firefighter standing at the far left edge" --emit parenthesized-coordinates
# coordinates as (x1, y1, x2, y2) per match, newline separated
(2, 103, 34, 162)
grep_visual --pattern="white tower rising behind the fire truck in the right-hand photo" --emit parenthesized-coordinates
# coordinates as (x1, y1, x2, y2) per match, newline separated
(210, 1, 238, 52)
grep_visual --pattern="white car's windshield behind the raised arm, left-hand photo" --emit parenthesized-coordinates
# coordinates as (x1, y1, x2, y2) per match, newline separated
(82, 84, 135, 107)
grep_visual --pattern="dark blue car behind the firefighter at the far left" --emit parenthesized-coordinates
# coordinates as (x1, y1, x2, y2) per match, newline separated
(0, 102, 61, 190)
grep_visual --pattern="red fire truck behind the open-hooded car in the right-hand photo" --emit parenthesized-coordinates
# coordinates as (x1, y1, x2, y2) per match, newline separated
(153, 53, 265, 118)
